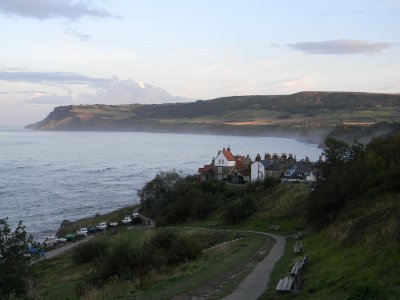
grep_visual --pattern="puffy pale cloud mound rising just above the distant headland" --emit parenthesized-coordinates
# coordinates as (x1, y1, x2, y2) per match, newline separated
(75, 77, 191, 104)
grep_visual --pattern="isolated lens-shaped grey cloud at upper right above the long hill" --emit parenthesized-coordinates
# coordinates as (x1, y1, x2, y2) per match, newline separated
(287, 39, 393, 55)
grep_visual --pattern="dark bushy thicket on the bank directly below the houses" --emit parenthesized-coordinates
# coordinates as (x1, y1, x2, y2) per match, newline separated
(138, 170, 278, 225)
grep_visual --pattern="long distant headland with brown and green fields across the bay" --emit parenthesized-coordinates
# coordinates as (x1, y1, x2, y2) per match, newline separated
(27, 92, 400, 141)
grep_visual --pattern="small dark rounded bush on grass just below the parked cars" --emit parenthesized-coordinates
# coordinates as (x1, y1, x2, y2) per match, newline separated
(72, 239, 108, 264)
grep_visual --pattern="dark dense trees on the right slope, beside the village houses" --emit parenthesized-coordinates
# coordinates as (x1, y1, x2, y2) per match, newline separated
(308, 134, 400, 227)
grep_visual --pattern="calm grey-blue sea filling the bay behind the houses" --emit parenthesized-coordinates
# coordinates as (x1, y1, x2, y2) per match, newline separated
(0, 127, 321, 240)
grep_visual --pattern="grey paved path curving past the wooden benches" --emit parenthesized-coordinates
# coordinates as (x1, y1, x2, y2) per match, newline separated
(175, 227, 286, 300)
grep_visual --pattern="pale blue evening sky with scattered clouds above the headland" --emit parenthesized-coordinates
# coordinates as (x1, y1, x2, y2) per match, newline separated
(0, 0, 400, 125)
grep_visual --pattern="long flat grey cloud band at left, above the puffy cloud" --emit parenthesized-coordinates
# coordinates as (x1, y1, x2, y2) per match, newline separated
(0, 71, 109, 84)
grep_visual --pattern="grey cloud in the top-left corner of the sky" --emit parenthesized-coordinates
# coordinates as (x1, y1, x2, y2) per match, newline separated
(0, 0, 114, 20)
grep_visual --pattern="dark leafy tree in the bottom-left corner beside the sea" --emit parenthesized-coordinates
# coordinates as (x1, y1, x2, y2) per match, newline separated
(0, 218, 40, 299)
